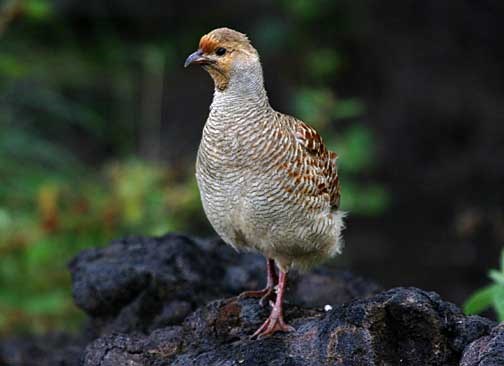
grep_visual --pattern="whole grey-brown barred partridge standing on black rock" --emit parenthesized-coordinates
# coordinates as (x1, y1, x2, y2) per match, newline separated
(184, 28, 345, 338)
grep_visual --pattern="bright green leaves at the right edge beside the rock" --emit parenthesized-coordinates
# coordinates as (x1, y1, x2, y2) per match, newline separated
(464, 249, 504, 321)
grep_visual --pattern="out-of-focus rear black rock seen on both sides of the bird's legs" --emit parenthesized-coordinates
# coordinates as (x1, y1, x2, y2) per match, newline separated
(69, 234, 379, 335)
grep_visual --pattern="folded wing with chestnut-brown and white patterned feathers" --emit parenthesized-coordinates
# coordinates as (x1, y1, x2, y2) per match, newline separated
(290, 117, 341, 209)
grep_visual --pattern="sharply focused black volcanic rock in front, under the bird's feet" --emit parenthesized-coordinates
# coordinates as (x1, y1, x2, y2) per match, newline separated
(83, 288, 493, 366)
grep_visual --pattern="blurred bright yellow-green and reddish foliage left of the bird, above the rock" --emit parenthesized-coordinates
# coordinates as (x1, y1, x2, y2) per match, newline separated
(0, 160, 202, 332)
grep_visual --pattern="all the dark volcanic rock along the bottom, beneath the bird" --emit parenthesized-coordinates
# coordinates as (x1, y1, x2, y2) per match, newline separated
(0, 234, 504, 366)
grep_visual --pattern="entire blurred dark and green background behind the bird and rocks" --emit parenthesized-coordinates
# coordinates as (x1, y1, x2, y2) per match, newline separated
(0, 0, 504, 334)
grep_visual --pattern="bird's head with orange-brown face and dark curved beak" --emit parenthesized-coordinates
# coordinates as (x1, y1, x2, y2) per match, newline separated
(184, 28, 262, 91)
